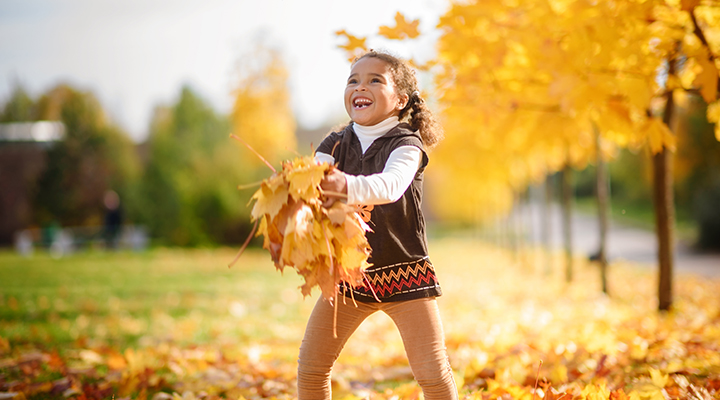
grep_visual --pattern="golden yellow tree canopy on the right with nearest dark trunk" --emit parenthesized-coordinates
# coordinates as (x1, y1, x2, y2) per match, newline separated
(338, 0, 720, 309)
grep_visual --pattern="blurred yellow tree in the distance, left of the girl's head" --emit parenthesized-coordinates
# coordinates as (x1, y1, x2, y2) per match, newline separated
(231, 47, 296, 166)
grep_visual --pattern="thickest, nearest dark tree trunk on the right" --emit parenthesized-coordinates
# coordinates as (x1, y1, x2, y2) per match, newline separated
(653, 59, 675, 311)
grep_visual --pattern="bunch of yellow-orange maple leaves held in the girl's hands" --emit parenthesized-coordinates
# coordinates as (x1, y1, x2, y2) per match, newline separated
(231, 148, 370, 300)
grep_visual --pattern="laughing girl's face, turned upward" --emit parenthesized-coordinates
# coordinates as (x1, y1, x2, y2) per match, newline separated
(345, 57, 408, 126)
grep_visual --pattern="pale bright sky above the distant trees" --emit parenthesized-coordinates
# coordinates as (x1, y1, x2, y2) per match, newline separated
(0, 0, 448, 142)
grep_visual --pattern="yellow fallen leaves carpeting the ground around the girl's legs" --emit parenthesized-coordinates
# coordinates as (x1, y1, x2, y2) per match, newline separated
(0, 239, 720, 400)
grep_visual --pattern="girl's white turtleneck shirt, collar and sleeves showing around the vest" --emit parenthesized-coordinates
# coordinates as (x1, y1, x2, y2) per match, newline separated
(315, 117, 422, 205)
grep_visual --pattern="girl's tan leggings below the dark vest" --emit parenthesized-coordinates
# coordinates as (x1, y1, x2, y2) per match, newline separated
(298, 297, 458, 400)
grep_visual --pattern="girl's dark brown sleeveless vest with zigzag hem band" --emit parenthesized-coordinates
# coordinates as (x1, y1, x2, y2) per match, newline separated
(317, 123, 442, 302)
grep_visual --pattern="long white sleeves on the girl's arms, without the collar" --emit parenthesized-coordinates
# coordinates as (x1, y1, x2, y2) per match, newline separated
(315, 146, 422, 205)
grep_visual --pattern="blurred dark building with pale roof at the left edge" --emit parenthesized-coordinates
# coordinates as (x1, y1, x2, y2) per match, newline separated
(0, 121, 65, 246)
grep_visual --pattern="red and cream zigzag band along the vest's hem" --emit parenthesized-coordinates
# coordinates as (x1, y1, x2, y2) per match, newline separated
(344, 257, 441, 301)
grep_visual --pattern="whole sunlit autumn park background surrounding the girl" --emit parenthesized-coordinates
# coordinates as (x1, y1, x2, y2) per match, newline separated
(0, 0, 720, 400)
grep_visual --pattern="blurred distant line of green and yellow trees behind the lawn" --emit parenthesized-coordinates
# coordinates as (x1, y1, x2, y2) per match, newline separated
(0, 36, 720, 253)
